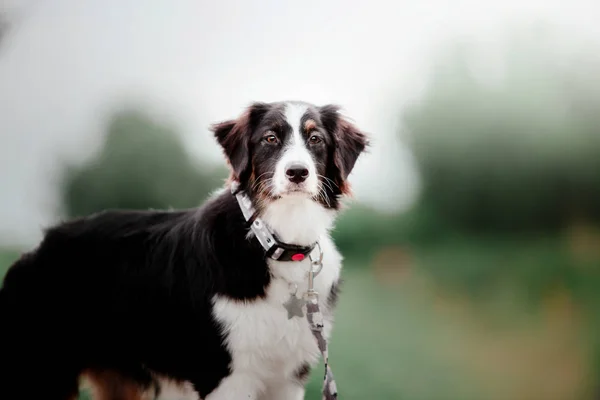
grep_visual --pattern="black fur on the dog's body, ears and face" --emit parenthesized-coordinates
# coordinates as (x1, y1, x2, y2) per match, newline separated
(0, 103, 366, 400)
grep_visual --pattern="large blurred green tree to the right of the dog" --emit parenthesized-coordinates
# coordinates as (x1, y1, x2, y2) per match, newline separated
(403, 27, 600, 232)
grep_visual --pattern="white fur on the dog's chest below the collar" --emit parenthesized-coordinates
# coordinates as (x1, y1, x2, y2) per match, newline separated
(213, 235, 342, 398)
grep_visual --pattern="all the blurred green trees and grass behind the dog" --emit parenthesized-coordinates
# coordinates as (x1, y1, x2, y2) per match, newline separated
(0, 3, 600, 400)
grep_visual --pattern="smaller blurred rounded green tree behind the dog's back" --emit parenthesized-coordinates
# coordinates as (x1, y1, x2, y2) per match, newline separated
(62, 110, 226, 217)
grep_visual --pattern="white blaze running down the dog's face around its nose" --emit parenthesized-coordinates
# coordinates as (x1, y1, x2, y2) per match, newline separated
(274, 103, 319, 195)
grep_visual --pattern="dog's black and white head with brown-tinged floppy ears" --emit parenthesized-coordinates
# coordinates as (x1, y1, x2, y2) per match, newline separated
(212, 102, 368, 209)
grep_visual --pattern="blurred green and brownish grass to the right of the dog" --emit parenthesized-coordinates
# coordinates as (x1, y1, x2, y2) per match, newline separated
(307, 238, 600, 400)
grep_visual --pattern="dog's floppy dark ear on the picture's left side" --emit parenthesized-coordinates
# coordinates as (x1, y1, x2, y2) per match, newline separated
(210, 103, 269, 182)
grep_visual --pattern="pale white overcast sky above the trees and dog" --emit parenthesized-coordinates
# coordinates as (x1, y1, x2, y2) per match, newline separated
(0, 0, 600, 244)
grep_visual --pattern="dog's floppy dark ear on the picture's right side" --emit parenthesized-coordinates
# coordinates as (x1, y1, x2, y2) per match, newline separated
(319, 105, 369, 194)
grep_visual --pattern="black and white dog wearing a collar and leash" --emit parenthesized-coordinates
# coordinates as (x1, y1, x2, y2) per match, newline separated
(0, 102, 368, 400)
